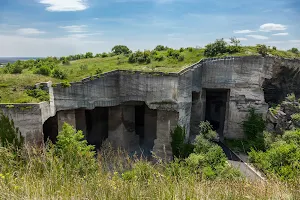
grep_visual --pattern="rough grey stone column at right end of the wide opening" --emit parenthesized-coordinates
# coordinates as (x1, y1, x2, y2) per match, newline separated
(153, 110, 178, 160)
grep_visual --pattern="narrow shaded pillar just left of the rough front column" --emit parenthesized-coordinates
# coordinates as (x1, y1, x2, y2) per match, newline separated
(143, 106, 157, 155)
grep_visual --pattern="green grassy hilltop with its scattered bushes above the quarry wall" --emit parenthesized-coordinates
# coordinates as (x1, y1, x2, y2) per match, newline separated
(0, 46, 300, 103)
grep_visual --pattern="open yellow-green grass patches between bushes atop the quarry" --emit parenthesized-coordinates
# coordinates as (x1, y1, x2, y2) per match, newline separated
(0, 47, 300, 103)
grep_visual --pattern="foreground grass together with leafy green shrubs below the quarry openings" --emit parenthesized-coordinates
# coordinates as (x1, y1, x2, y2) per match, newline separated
(0, 120, 299, 199)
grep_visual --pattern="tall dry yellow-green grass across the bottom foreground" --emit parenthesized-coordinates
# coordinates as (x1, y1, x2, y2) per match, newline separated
(0, 146, 300, 200)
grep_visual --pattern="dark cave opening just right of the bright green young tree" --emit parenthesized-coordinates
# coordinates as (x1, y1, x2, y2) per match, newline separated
(85, 107, 108, 149)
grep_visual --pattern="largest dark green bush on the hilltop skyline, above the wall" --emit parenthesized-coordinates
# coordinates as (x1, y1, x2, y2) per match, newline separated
(204, 38, 227, 57)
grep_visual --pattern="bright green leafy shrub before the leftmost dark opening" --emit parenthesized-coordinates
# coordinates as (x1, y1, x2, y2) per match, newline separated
(54, 123, 97, 174)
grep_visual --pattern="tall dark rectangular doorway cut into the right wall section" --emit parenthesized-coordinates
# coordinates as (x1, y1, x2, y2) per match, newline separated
(205, 89, 229, 140)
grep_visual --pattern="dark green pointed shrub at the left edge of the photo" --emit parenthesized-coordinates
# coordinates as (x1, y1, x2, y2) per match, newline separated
(0, 113, 24, 150)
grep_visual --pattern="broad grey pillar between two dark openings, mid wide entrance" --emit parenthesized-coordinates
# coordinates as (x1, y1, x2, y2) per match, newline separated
(108, 105, 139, 152)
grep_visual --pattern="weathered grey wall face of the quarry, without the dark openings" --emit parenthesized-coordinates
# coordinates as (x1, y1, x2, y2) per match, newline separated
(0, 56, 300, 151)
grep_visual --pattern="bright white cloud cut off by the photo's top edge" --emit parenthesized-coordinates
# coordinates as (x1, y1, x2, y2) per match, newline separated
(39, 0, 88, 12)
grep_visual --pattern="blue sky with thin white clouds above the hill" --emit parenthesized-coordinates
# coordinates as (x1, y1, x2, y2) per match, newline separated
(0, 0, 300, 56)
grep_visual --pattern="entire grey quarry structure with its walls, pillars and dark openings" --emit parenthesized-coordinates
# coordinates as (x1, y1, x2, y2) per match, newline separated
(0, 56, 300, 157)
